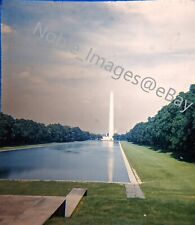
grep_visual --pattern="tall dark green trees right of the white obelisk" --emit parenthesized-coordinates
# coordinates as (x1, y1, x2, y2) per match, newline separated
(118, 90, 195, 160)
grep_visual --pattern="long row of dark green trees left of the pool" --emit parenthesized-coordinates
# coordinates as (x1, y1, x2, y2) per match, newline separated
(0, 113, 101, 146)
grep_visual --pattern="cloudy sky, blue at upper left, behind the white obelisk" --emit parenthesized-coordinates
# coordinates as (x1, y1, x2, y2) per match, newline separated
(2, 0, 195, 133)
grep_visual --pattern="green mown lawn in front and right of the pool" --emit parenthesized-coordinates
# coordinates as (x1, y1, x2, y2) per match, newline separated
(0, 142, 195, 225)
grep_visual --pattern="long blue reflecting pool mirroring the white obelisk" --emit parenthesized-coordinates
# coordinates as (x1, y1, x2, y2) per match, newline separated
(0, 141, 129, 182)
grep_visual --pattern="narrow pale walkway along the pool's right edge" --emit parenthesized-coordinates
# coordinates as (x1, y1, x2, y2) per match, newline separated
(119, 142, 145, 198)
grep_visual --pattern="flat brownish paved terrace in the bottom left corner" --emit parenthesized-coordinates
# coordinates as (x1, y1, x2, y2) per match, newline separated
(0, 195, 65, 225)
